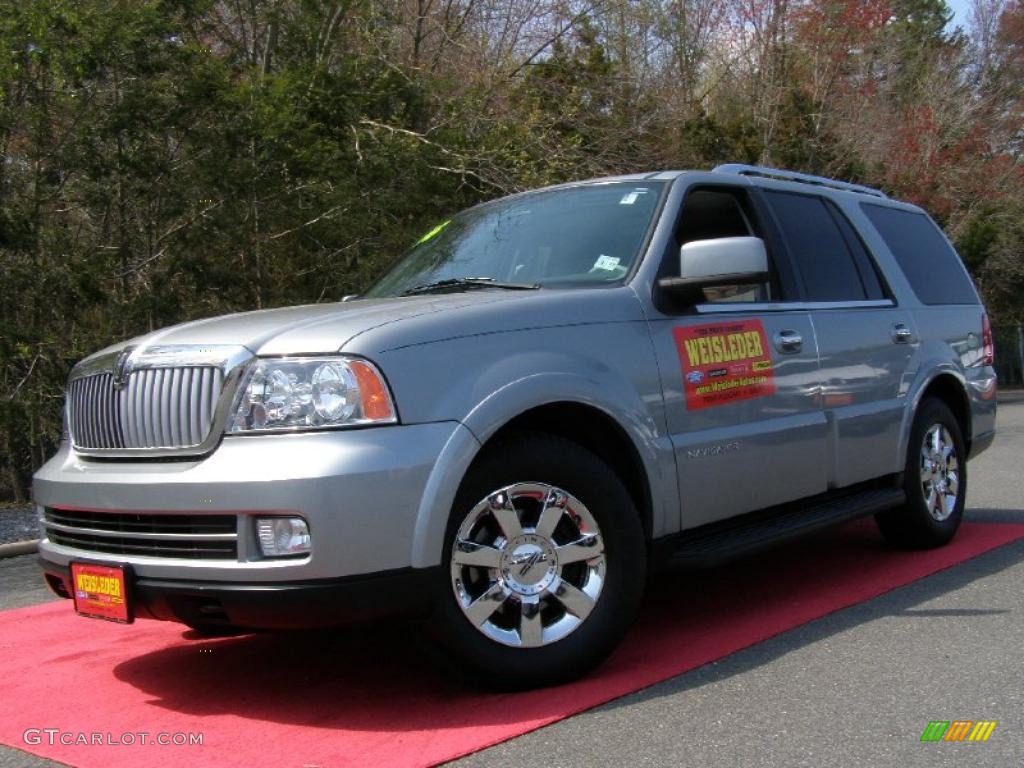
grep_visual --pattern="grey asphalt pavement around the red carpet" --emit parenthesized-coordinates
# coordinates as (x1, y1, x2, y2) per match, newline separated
(0, 393, 1024, 768)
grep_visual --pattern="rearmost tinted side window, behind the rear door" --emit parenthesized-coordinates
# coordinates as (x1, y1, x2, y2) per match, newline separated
(860, 203, 978, 304)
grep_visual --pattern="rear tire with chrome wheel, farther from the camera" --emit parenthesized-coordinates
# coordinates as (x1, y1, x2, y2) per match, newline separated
(874, 398, 967, 549)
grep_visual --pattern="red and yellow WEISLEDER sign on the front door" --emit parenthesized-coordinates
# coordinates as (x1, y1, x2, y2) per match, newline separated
(672, 321, 775, 411)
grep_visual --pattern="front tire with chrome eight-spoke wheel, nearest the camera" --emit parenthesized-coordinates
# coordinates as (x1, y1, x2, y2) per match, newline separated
(431, 433, 646, 689)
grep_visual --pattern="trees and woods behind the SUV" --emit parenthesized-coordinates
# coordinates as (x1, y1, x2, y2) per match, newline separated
(0, 0, 1024, 501)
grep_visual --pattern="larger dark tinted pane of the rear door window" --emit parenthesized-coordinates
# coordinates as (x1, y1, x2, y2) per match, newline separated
(765, 191, 867, 301)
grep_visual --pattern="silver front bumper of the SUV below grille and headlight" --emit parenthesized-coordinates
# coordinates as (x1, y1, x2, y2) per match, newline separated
(33, 422, 468, 581)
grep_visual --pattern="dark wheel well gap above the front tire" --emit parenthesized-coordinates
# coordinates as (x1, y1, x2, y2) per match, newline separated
(483, 402, 652, 542)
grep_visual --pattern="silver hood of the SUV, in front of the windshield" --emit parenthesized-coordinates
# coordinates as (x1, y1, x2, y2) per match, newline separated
(80, 291, 515, 359)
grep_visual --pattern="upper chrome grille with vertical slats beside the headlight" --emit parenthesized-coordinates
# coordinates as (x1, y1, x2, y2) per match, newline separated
(68, 366, 224, 450)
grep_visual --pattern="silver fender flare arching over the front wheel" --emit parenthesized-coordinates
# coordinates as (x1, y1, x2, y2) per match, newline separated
(412, 372, 679, 567)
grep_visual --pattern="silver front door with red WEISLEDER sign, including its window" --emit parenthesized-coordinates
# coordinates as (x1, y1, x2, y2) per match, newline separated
(650, 184, 827, 528)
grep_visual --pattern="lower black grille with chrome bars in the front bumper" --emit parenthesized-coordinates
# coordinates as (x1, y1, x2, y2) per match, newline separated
(43, 508, 239, 560)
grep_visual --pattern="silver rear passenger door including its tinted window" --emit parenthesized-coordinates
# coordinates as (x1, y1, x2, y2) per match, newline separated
(764, 190, 919, 487)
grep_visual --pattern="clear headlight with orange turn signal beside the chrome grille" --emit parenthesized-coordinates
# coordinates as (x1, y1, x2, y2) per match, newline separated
(227, 356, 397, 432)
